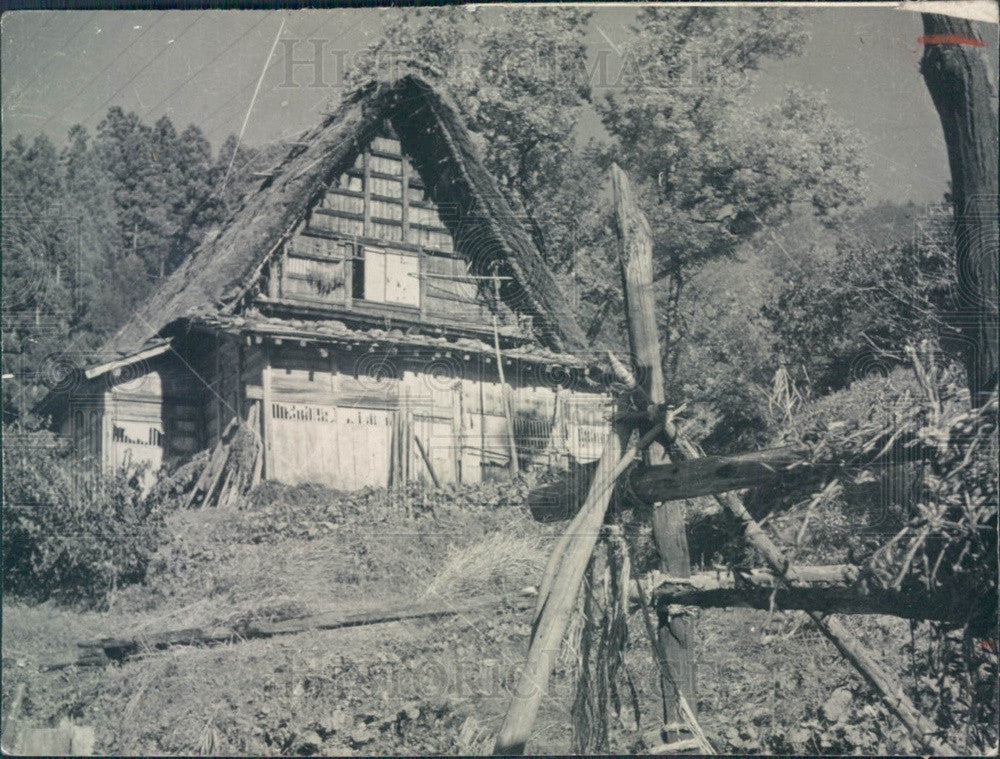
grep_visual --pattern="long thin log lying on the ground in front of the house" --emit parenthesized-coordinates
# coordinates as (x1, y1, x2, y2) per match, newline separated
(53, 598, 533, 670)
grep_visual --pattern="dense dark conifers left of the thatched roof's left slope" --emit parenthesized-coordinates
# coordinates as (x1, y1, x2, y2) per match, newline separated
(2, 120, 266, 422)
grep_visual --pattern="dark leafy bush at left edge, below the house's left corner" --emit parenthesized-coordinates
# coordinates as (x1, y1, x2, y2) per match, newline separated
(3, 432, 175, 605)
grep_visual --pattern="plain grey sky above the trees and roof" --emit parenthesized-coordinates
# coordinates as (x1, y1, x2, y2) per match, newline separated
(0, 7, 997, 204)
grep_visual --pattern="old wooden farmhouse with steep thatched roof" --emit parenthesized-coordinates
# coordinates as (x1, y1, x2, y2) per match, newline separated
(44, 74, 609, 489)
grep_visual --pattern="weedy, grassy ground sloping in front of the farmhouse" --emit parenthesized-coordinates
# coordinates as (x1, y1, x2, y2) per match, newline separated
(3, 492, 940, 755)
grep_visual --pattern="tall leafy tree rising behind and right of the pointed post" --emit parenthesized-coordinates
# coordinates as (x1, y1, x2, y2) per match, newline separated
(597, 7, 862, 383)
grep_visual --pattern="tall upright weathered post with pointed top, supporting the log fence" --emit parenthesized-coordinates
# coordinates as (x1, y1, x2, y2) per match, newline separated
(611, 164, 697, 742)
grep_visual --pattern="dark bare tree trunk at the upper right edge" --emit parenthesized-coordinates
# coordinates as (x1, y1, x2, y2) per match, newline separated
(920, 13, 997, 405)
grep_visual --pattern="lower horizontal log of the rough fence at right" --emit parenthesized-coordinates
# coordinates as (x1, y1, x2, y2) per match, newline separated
(652, 564, 978, 624)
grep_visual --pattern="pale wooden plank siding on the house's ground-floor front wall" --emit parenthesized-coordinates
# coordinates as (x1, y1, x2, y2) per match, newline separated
(268, 343, 611, 490)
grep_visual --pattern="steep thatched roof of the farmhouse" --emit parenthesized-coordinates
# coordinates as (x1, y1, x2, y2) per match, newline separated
(101, 74, 585, 364)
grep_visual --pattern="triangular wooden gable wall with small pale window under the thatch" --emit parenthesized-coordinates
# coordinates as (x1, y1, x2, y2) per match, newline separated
(259, 119, 530, 334)
